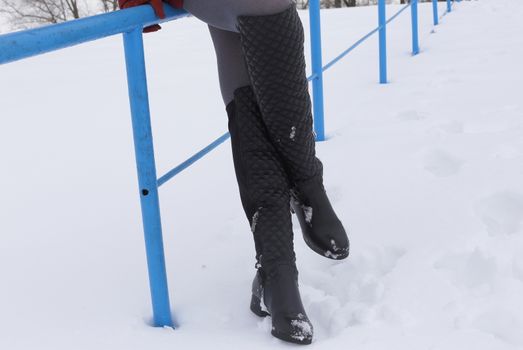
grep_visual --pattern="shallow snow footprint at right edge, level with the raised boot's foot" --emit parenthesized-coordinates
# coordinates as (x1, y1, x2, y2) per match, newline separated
(475, 191, 523, 236)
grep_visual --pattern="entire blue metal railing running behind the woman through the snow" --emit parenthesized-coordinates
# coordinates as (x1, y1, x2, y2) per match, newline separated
(0, 0, 460, 327)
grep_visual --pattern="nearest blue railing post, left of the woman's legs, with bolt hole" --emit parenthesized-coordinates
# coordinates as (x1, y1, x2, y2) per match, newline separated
(123, 27, 173, 327)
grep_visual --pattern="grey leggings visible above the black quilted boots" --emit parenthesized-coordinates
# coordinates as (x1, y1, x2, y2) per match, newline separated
(184, 0, 293, 105)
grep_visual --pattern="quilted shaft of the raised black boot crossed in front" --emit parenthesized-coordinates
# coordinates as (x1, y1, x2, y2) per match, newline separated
(238, 6, 322, 184)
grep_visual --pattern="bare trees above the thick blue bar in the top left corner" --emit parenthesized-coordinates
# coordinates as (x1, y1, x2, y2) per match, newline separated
(0, 0, 84, 28)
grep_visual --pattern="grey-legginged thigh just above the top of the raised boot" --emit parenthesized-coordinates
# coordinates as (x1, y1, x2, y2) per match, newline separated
(183, 0, 293, 32)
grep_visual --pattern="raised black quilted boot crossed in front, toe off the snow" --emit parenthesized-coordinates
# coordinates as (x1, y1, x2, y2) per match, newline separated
(238, 6, 349, 260)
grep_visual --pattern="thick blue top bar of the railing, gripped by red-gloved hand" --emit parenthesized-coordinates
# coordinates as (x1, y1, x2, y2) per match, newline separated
(0, 5, 189, 64)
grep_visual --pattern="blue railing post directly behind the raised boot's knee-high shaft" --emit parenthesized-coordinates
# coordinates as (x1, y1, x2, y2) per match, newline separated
(309, 0, 325, 141)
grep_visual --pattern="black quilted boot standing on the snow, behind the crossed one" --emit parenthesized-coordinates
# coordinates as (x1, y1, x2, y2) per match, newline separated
(227, 86, 313, 344)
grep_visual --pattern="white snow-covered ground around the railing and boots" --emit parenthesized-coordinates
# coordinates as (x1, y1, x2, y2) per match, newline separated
(0, 0, 523, 350)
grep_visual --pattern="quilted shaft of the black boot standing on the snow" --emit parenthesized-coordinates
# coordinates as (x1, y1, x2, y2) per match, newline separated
(228, 86, 295, 274)
